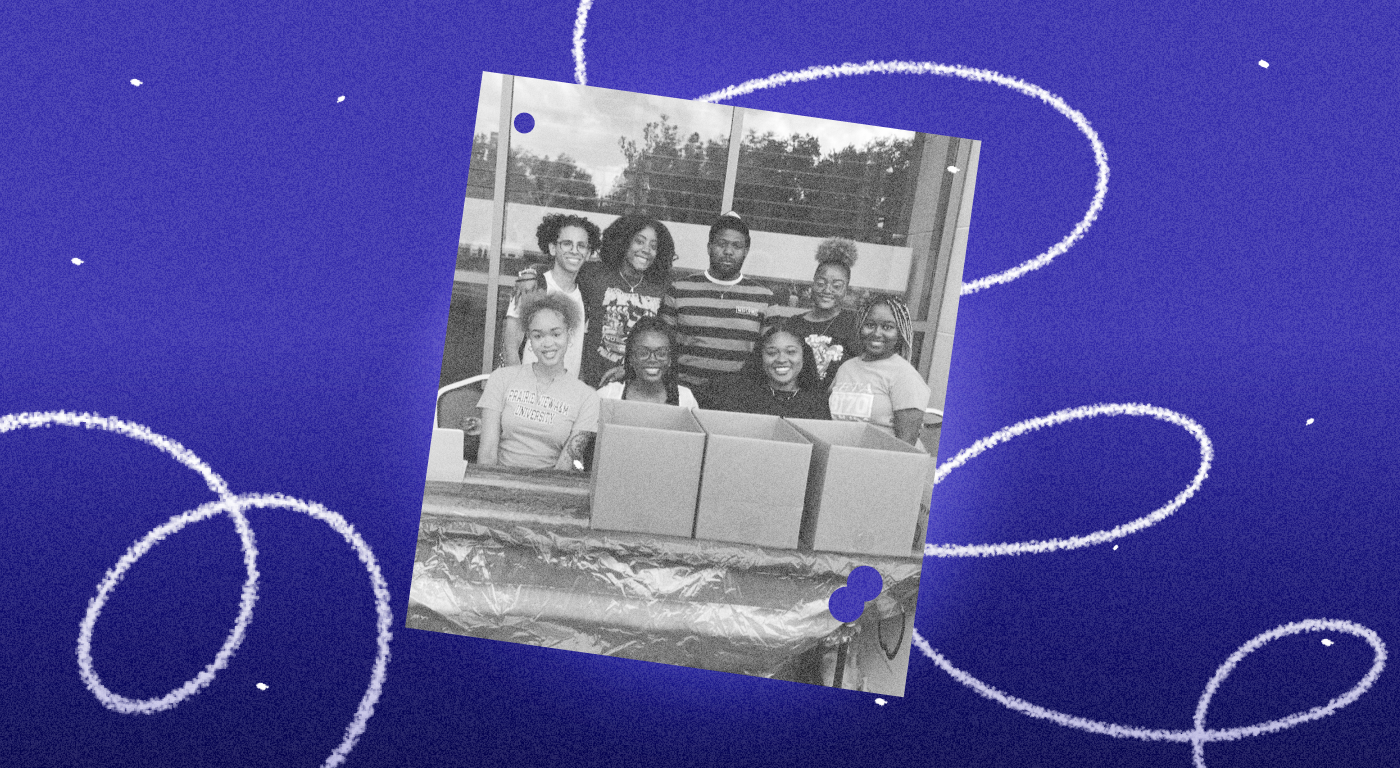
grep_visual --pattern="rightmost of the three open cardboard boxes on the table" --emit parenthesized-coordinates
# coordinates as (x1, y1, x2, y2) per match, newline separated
(787, 418, 934, 557)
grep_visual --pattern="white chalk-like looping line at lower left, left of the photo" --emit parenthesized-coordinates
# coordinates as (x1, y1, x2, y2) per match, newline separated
(0, 411, 393, 768)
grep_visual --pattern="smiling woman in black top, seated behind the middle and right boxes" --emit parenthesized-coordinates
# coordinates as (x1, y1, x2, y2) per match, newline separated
(700, 322, 832, 418)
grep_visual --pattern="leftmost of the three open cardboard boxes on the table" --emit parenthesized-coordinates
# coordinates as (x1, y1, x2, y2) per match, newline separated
(591, 400, 704, 537)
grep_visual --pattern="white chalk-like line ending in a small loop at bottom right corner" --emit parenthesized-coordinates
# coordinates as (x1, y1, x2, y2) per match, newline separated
(913, 618, 1386, 768)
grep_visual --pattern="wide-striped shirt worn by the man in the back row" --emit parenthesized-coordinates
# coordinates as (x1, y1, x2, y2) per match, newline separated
(661, 273, 773, 387)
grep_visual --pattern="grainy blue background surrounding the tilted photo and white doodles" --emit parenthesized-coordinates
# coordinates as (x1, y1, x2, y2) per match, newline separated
(0, 0, 1400, 767)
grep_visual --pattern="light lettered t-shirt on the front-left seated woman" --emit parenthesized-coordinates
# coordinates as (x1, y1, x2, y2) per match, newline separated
(479, 362, 598, 469)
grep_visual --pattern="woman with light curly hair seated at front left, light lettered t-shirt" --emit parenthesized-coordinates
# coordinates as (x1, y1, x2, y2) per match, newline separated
(477, 291, 598, 470)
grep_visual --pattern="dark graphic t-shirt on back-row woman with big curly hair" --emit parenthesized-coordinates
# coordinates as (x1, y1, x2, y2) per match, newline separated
(578, 262, 666, 386)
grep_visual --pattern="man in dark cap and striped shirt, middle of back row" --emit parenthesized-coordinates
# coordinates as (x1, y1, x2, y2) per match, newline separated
(661, 214, 773, 387)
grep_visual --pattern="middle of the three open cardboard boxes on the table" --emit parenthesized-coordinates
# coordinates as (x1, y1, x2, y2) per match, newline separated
(694, 410, 812, 550)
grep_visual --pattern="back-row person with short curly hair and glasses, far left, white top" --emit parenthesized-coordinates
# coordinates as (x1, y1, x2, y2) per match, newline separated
(501, 214, 602, 376)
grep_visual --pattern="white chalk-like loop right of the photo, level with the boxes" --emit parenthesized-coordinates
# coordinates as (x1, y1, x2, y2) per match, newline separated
(924, 403, 1215, 557)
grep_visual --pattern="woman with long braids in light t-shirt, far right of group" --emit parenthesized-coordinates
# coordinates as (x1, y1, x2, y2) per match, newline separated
(830, 297, 930, 445)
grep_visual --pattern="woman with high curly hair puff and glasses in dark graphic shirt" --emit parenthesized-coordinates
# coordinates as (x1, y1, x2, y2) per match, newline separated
(788, 238, 862, 387)
